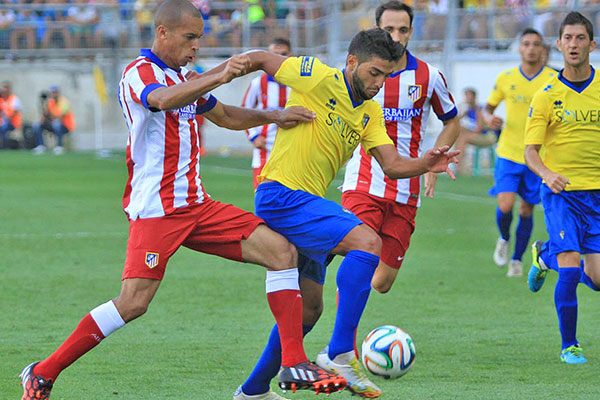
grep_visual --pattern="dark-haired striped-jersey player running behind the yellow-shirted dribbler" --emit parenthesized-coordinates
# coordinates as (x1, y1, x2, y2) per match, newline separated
(342, 1, 459, 293)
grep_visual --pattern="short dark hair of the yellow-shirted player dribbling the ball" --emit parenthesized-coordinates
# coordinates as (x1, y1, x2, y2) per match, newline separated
(348, 28, 404, 63)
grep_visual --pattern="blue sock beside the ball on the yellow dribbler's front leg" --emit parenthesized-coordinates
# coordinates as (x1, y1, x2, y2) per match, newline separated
(329, 250, 379, 360)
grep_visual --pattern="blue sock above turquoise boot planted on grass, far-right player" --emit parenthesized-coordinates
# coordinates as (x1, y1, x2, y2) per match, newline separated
(554, 267, 581, 350)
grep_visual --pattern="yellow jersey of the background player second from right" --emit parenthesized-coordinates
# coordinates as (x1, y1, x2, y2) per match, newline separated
(487, 66, 556, 164)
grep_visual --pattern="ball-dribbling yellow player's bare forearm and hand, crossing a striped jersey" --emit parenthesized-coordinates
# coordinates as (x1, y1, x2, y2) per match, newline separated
(371, 144, 460, 179)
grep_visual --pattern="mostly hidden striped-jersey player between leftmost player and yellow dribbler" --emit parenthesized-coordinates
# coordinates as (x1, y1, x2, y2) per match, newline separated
(242, 38, 292, 189)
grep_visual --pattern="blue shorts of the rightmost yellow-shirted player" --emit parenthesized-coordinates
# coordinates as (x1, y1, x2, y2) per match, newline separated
(540, 184, 600, 255)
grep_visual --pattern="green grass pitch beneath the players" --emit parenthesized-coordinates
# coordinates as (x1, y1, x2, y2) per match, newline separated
(0, 152, 600, 400)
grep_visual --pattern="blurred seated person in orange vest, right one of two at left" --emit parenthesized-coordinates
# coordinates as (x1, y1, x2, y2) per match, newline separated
(33, 85, 75, 154)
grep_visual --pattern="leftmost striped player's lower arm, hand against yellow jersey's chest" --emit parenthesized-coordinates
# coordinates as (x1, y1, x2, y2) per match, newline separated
(203, 102, 316, 130)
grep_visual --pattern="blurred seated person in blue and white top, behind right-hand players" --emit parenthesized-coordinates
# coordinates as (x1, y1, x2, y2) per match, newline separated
(454, 88, 498, 174)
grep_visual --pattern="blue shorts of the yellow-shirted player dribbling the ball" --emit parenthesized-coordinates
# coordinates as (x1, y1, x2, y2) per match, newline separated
(254, 182, 362, 278)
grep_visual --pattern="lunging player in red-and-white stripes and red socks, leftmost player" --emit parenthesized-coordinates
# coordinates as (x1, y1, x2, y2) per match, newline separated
(21, 0, 345, 400)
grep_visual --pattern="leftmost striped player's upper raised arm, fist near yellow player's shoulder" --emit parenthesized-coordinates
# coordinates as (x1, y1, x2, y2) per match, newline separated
(147, 54, 248, 110)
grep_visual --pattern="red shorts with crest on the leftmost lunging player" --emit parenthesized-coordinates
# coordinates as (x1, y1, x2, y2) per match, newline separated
(122, 199, 264, 280)
